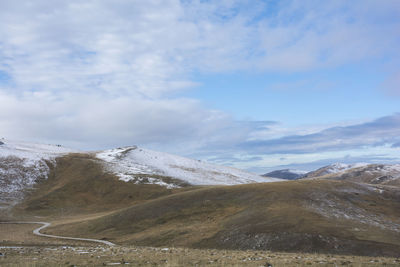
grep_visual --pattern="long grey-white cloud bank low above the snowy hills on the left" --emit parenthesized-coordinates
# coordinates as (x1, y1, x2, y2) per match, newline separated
(0, 93, 238, 151)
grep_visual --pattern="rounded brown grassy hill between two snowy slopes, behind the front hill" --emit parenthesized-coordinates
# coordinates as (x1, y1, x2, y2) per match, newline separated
(14, 154, 191, 217)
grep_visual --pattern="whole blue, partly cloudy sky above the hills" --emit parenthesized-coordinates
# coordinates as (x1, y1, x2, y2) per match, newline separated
(0, 0, 400, 173)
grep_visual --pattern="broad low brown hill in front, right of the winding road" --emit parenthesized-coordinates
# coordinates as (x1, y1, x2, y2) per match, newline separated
(49, 180, 400, 256)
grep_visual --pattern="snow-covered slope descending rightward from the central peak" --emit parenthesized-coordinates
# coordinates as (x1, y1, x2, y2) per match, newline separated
(97, 146, 281, 187)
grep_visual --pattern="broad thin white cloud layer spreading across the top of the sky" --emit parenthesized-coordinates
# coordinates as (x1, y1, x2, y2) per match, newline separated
(0, 0, 400, 94)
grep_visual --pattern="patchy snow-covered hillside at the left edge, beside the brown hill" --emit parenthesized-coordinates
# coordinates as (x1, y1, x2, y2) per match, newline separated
(0, 139, 72, 209)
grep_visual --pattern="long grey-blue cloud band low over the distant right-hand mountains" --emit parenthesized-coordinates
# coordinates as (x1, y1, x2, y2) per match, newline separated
(239, 114, 400, 154)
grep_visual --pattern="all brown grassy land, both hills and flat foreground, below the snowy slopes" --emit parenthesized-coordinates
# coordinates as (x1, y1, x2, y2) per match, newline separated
(0, 155, 400, 266)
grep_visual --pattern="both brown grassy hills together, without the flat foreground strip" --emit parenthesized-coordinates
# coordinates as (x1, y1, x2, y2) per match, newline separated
(8, 154, 400, 257)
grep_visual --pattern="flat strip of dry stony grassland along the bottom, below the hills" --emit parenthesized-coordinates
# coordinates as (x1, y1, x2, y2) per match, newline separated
(0, 224, 400, 267)
